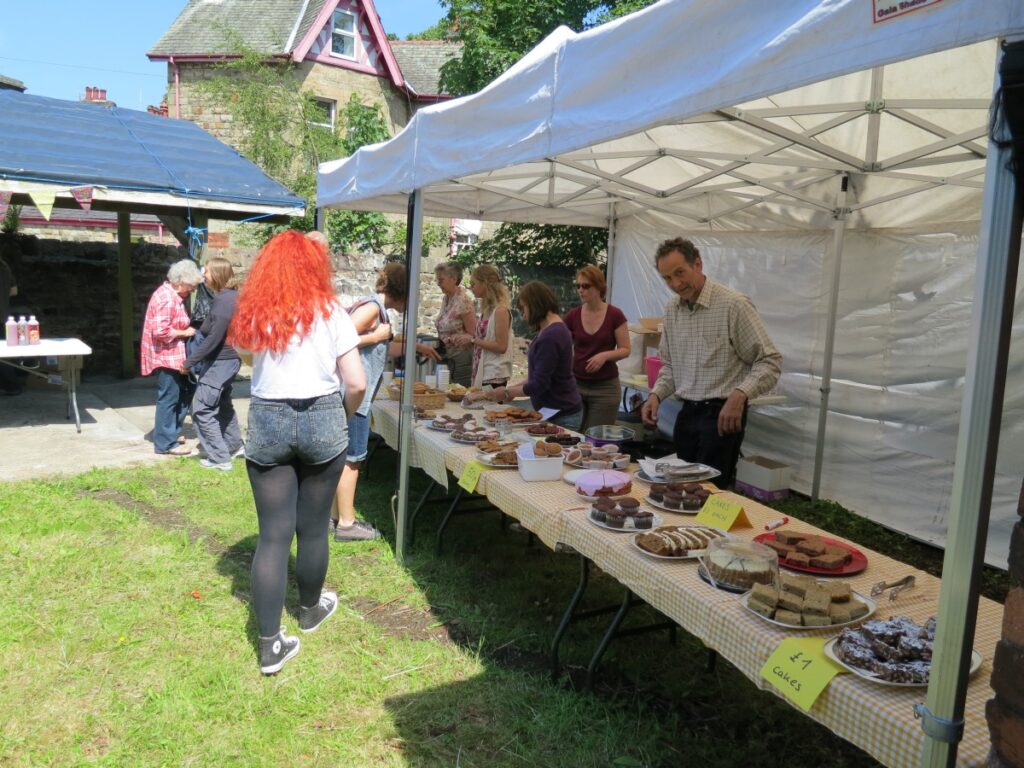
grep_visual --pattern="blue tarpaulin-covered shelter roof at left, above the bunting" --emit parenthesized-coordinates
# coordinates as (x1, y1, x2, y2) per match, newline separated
(0, 90, 305, 220)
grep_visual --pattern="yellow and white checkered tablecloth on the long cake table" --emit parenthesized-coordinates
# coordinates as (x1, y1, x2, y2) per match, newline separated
(364, 403, 1002, 768)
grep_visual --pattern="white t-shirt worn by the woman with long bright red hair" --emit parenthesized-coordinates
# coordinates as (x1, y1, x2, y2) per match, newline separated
(251, 305, 359, 400)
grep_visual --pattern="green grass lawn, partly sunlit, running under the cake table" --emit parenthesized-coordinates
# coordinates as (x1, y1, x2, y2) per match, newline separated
(0, 452, 999, 768)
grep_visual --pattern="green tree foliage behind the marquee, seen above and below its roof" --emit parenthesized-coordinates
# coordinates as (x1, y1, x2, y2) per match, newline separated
(440, 0, 654, 267)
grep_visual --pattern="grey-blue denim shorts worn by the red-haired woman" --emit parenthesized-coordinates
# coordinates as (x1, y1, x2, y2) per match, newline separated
(246, 392, 348, 467)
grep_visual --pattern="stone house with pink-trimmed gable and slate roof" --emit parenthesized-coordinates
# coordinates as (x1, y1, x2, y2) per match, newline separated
(147, 0, 461, 323)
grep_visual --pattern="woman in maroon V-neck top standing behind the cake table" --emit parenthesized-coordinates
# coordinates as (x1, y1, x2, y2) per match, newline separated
(564, 266, 630, 432)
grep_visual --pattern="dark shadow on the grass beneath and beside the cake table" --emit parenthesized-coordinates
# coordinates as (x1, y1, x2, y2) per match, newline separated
(332, 451, 878, 768)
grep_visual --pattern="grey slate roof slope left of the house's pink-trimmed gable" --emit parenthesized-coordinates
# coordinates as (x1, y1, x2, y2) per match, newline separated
(148, 0, 307, 56)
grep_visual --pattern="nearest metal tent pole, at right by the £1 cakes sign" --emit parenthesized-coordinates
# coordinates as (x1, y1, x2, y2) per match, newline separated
(914, 41, 1024, 768)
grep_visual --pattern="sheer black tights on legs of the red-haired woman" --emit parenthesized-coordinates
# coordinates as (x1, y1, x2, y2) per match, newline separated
(246, 452, 345, 637)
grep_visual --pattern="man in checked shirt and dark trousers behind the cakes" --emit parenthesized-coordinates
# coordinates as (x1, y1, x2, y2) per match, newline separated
(640, 238, 782, 487)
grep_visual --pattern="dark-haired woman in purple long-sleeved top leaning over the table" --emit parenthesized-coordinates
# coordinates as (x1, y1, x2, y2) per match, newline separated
(486, 281, 583, 430)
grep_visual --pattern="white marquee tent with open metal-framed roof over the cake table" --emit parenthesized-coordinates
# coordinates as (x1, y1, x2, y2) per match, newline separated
(318, 0, 1024, 765)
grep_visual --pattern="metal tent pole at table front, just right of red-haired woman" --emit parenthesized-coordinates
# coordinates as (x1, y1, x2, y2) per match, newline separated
(394, 189, 423, 563)
